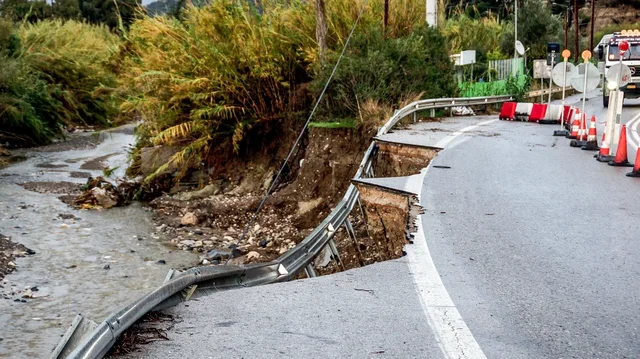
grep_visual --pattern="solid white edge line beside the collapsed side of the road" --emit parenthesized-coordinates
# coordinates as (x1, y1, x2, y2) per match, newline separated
(407, 120, 497, 359)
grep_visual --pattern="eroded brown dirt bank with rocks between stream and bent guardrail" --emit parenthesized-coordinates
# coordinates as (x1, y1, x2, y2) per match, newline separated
(150, 128, 373, 264)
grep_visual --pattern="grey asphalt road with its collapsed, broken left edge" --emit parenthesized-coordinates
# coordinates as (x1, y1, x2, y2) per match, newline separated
(120, 93, 640, 359)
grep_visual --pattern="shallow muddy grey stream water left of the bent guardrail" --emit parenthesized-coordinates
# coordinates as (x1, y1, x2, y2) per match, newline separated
(0, 129, 197, 358)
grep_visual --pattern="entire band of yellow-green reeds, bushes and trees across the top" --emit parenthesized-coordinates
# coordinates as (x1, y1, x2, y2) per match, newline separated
(0, 0, 624, 180)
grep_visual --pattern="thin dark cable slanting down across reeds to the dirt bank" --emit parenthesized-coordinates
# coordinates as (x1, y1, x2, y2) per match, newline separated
(227, 0, 369, 263)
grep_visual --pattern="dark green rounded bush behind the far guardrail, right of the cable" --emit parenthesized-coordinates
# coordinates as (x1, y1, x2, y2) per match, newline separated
(312, 27, 456, 121)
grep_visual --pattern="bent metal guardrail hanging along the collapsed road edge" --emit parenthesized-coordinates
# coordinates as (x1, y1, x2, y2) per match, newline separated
(51, 96, 513, 359)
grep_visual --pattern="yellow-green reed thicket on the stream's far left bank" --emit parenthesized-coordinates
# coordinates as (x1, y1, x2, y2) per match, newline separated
(0, 20, 119, 146)
